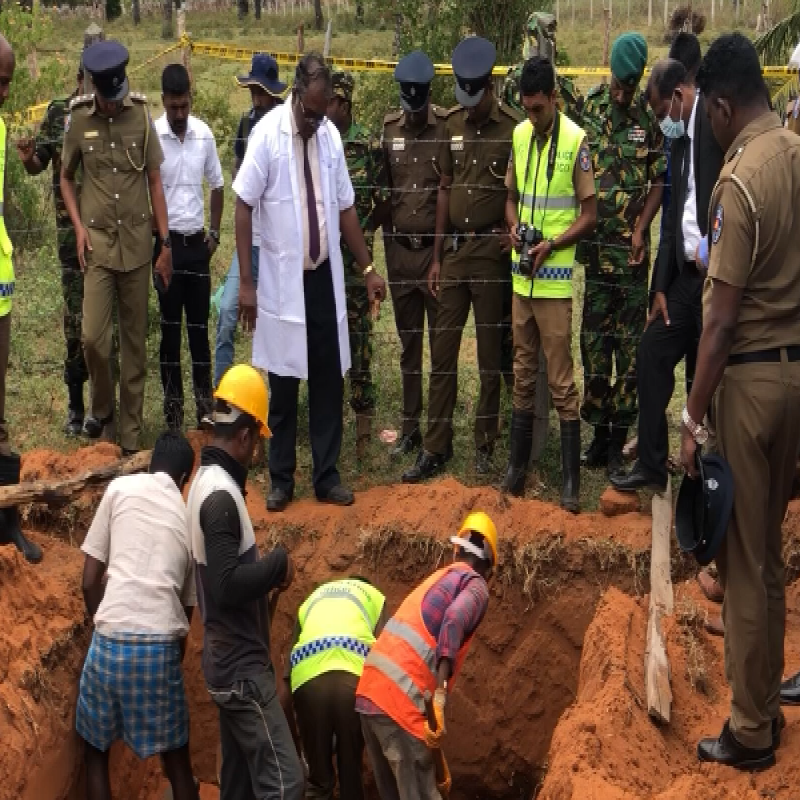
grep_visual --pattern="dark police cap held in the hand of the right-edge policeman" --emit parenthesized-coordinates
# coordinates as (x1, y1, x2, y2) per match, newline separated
(675, 455, 734, 566)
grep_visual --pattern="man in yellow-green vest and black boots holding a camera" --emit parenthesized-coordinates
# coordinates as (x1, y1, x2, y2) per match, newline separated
(501, 56, 597, 513)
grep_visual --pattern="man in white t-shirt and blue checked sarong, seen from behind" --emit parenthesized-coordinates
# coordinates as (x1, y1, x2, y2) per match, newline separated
(75, 433, 198, 800)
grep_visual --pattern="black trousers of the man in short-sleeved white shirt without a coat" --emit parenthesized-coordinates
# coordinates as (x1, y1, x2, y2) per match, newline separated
(153, 233, 211, 429)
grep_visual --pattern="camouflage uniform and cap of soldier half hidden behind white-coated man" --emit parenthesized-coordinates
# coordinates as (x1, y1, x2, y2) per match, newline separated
(334, 73, 385, 414)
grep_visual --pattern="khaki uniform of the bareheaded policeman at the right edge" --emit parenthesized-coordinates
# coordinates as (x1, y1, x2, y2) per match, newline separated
(704, 112, 800, 748)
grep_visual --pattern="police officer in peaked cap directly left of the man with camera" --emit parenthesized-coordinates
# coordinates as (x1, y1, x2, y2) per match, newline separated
(403, 36, 519, 483)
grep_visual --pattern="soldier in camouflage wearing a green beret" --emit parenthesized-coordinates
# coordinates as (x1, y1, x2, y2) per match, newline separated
(581, 33, 667, 475)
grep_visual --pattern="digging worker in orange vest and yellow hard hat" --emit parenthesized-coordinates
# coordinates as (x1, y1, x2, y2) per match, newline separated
(356, 511, 497, 800)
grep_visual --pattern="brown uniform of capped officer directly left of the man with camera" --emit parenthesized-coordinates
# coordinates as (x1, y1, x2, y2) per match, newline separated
(424, 103, 522, 456)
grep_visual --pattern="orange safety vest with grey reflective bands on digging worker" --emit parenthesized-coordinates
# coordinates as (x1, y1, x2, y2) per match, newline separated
(356, 564, 482, 739)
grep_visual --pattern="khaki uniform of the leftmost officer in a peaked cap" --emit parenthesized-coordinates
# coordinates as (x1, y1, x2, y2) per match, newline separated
(63, 94, 163, 450)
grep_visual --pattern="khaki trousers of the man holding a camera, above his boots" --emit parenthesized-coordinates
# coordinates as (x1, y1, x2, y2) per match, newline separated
(511, 292, 579, 422)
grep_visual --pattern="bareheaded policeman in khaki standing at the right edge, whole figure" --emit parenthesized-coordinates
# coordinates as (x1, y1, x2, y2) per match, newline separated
(681, 33, 800, 769)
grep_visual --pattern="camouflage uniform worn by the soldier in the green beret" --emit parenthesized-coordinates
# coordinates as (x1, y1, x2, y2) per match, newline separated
(581, 86, 667, 428)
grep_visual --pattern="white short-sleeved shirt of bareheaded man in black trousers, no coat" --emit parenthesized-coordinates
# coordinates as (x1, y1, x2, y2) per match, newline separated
(155, 114, 225, 234)
